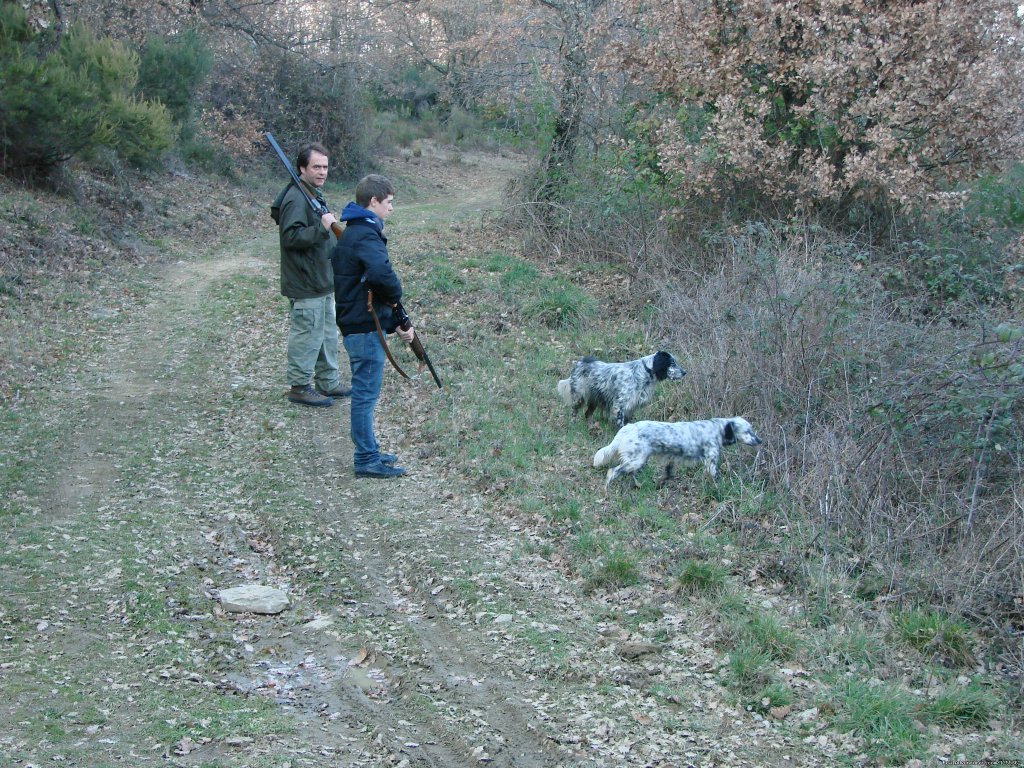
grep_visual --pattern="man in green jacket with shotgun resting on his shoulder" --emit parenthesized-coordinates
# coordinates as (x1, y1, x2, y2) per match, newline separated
(270, 143, 351, 407)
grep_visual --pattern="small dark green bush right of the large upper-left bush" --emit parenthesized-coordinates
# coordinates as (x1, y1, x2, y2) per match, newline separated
(137, 30, 213, 125)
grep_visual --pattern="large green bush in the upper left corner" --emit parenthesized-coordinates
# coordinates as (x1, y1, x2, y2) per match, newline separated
(0, 3, 172, 173)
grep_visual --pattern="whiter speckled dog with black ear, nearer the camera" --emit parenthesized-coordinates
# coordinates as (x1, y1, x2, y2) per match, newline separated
(594, 416, 761, 487)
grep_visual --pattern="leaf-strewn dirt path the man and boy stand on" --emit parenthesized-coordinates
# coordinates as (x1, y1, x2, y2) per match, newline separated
(0, 145, 836, 768)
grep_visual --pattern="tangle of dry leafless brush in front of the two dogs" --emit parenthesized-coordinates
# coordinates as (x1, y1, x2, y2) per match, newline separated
(640, 218, 1024, 626)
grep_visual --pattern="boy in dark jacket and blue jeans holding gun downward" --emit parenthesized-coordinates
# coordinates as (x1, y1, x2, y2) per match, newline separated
(331, 174, 415, 477)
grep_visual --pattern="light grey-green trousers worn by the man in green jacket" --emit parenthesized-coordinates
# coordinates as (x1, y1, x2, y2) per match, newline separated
(287, 294, 341, 392)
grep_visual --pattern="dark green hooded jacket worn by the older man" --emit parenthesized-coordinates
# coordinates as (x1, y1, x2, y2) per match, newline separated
(270, 183, 335, 299)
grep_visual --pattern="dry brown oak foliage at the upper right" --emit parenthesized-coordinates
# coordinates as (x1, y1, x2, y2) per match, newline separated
(623, 0, 1024, 210)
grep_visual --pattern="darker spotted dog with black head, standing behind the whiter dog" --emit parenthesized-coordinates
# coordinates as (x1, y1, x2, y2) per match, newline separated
(558, 352, 686, 427)
